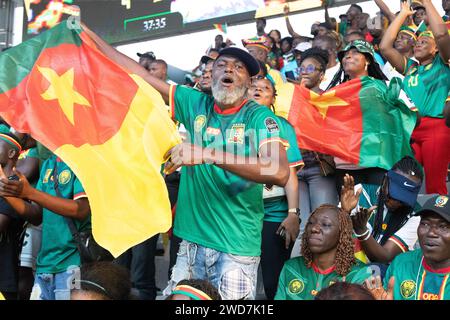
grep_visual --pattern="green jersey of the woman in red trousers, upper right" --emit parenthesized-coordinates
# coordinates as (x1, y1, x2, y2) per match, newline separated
(403, 55, 450, 118)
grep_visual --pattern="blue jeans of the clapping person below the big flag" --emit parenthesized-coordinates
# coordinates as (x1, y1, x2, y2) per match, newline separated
(30, 267, 80, 300)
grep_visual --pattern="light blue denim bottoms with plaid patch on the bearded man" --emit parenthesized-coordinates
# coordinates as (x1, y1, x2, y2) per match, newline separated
(163, 240, 260, 300)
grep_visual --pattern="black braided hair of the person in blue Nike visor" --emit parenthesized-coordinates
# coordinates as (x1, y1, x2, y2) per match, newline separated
(372, 156, 423, 245)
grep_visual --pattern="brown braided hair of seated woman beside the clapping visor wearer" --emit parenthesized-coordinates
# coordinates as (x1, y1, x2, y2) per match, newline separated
(301, 204, 355, 276)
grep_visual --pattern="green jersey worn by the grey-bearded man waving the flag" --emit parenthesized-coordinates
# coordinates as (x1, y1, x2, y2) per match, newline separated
(170, 86, 282, 256)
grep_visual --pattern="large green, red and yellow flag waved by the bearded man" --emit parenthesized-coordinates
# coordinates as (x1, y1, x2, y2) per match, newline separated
(0, 22, 180, 256)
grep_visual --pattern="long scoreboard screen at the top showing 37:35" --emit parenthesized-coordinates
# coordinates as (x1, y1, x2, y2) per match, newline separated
(24, 0, 366, 45)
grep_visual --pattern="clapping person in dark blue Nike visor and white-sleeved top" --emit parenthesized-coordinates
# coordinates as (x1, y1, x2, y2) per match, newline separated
(341, 156, 423, 274)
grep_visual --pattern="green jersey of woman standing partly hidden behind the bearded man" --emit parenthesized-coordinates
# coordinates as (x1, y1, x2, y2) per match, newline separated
(263, 117, 303, 222)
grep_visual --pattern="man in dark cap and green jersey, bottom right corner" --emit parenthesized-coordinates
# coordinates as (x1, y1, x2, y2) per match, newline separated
(369, 195, 450, 300)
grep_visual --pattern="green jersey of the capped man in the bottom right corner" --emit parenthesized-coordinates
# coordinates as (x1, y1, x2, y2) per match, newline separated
(384, 249, 450, 300)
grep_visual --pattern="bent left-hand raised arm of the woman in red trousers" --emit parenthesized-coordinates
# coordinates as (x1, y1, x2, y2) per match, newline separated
(380, 2, 414, 73)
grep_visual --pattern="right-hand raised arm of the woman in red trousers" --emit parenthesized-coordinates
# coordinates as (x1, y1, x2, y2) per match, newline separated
(422, 0, 450, 63)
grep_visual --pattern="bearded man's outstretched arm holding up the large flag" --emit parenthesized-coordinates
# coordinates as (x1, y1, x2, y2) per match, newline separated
(81, 23, 170, 104)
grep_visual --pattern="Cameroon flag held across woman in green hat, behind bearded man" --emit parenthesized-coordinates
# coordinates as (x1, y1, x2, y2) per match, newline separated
(277, 77, 416, 169)
